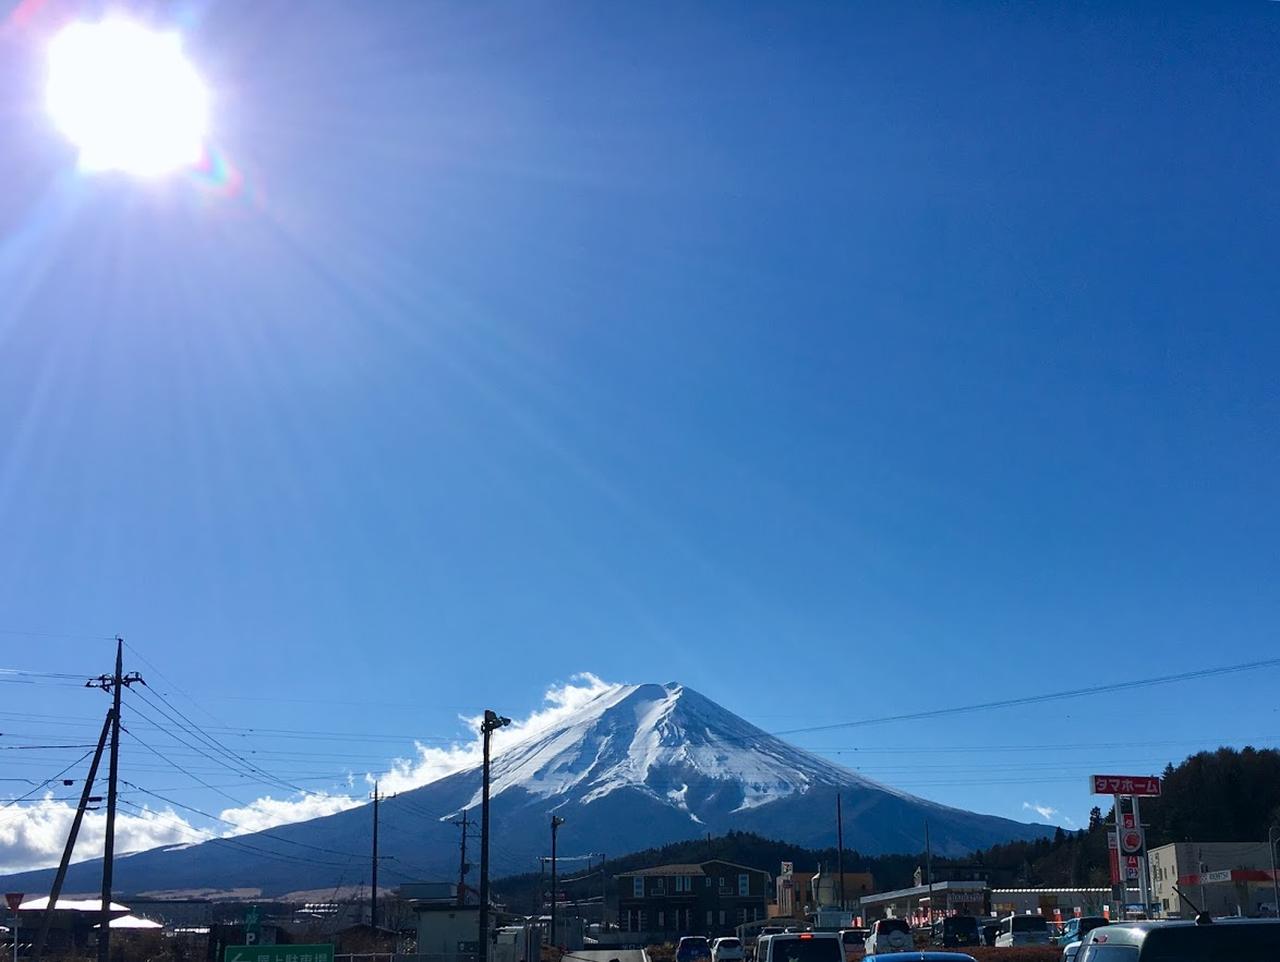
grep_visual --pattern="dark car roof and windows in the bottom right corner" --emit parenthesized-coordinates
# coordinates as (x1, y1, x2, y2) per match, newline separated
(1076, 919, 1280, 962)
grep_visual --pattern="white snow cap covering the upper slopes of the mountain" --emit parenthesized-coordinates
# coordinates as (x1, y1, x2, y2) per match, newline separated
(465, 683, 928, 821)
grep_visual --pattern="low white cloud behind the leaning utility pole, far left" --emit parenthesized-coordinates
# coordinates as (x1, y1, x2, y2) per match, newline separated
(0, 797, 203, 874)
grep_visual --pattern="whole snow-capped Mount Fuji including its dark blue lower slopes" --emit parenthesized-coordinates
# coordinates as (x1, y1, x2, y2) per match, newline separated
(5, 683, 1053, 895)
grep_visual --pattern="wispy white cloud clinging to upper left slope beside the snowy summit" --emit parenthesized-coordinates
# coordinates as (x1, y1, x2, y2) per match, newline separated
(365, 672, 618, 794)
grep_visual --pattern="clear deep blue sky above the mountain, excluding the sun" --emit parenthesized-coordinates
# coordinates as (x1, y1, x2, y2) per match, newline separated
(0, 1, 1280, 869)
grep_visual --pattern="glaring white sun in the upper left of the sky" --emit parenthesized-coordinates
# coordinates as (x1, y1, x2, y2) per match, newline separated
(46, 19, 209, 177)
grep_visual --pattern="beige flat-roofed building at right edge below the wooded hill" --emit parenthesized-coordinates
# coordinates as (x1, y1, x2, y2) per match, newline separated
(1147, 842, 1276, 919)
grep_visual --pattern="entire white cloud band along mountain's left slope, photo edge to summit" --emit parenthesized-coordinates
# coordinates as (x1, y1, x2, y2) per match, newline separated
(0, 673, 617, 874)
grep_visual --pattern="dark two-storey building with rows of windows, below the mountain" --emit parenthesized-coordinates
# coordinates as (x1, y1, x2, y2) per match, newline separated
(617, 858, 769, 940)
